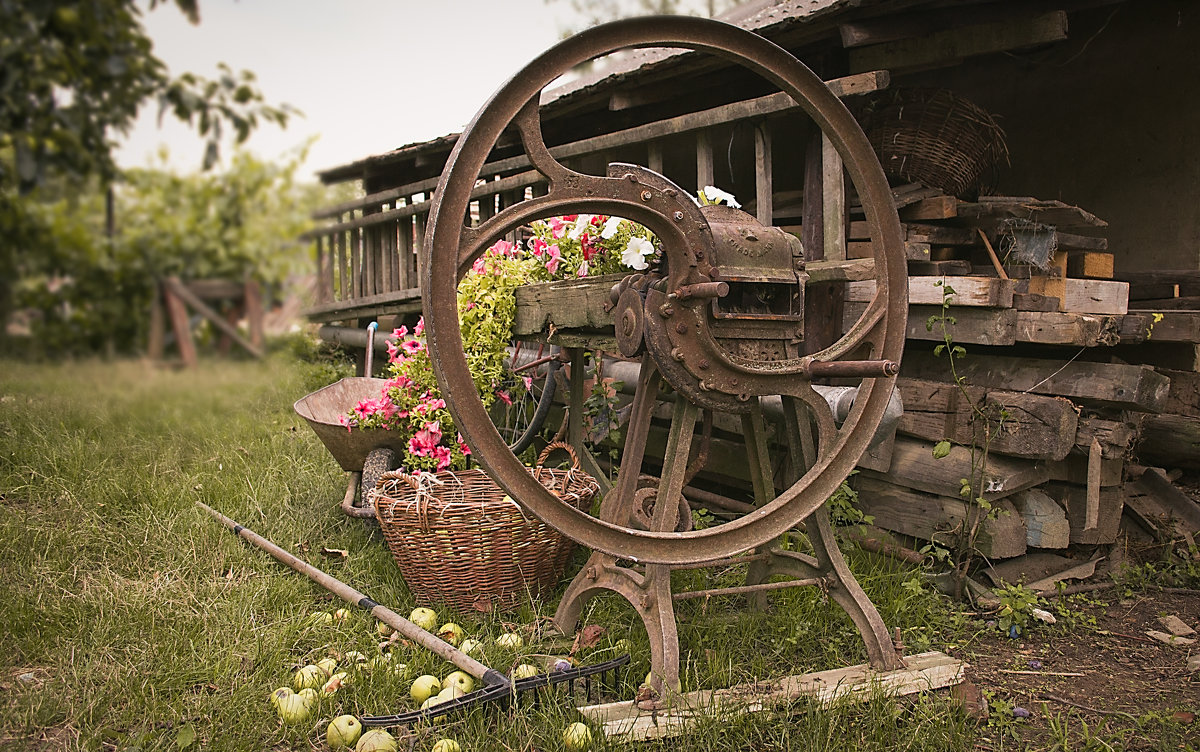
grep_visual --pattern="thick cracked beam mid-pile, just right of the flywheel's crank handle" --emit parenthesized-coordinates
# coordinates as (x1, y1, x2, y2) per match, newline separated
(896, 377, 1079, 459)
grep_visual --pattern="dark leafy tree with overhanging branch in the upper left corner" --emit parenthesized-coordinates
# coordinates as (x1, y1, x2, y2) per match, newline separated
(0, 0, 294, 345)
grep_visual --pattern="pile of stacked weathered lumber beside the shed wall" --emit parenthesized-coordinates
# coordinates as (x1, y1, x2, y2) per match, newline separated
(845, 187, 1200, 559)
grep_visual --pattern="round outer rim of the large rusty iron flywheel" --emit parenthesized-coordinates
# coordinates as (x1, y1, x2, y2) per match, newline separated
(421, 17, 907, 564)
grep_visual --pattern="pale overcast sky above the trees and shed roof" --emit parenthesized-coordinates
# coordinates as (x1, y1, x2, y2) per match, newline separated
(116, 0, 570, 178)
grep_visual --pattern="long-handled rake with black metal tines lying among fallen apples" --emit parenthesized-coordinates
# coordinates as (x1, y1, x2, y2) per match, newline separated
(196, 501, 630, 726)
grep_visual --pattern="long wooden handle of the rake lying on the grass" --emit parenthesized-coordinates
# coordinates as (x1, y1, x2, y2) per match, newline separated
(196, 501, 512, 687)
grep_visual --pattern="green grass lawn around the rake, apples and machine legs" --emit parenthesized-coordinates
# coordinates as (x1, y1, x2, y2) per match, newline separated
(0, 355, 1186, 751)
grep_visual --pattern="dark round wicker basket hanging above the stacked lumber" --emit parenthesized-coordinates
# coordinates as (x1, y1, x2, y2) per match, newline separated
(863, 89, 1008, 199)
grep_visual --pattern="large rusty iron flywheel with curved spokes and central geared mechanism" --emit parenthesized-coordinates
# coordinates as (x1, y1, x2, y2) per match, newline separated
(421, 17, 907, 565)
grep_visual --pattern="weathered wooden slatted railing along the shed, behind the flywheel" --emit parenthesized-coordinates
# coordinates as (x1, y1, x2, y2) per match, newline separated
(305, 71, 889, 321)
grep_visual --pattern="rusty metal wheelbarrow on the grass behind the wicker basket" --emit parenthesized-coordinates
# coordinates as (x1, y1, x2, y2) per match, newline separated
(292, 321, 407, 518)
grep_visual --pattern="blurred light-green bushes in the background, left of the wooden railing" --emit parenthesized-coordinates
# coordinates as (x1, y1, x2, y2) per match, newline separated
(8, 152, 324, 354)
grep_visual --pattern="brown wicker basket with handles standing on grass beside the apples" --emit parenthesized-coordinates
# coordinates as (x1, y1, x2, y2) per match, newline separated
(372, 443, 600, 610)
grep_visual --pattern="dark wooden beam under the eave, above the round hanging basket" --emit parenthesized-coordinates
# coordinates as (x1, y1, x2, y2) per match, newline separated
(848, 11, 1067, 71)
